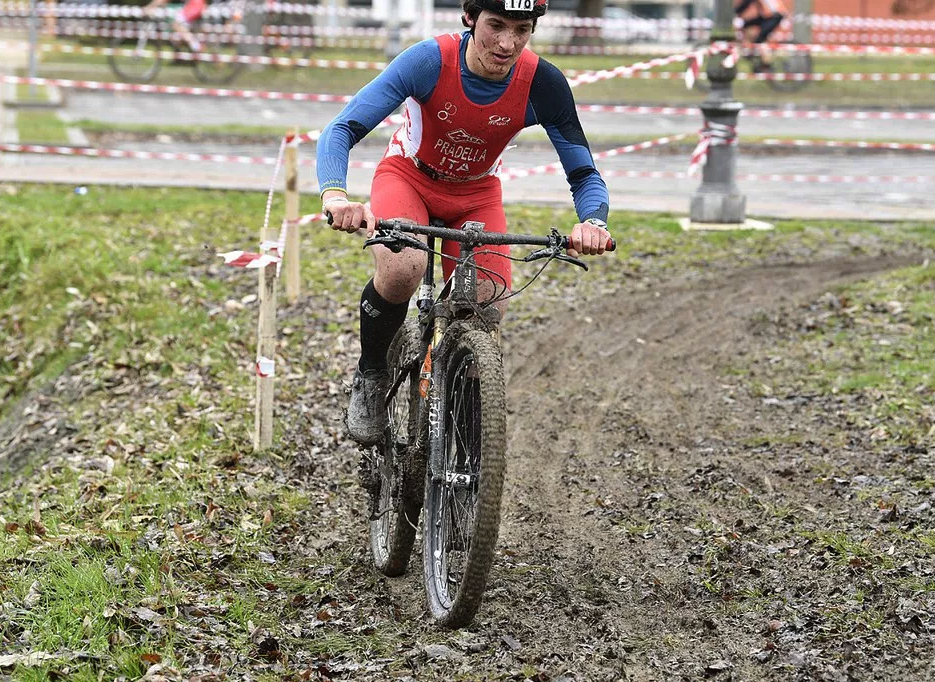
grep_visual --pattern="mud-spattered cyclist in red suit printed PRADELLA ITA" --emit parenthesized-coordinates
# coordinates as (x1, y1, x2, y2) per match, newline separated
(317, 0, 609, 445)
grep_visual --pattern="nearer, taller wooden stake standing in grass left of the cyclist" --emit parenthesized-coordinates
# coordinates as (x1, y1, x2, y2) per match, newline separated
(253, 252, 277, 450)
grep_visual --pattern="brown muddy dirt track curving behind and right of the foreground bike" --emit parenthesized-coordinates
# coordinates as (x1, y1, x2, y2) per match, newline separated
(290, 252, 935, 682)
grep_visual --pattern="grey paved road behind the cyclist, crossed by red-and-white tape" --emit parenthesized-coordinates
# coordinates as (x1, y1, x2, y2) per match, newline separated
(0, 92, 935, 220)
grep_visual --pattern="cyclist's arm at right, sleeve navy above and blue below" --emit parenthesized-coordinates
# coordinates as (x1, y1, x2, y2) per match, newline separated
(526, 59, 610, 222)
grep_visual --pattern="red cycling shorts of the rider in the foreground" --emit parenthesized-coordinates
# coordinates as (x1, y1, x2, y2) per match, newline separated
(370, 156, 513, 289)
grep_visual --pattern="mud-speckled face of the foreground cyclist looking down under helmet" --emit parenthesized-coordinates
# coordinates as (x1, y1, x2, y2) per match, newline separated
(467, 10, 532, 80)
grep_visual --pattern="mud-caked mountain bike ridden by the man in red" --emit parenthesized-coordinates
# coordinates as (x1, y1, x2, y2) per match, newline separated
(361, 220, 616, 628)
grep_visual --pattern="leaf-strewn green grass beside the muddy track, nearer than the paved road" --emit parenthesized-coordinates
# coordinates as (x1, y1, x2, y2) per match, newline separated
(0, 185, 935, 680)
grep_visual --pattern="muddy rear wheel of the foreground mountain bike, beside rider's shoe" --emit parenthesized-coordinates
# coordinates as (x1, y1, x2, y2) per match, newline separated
(370, 321, 425, 576)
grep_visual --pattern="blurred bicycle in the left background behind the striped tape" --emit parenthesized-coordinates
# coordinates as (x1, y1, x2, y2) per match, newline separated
(107, 4, 245, 85)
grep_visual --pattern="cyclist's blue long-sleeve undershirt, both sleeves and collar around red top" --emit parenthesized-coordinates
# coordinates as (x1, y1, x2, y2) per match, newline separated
(317, 32, 610, 220)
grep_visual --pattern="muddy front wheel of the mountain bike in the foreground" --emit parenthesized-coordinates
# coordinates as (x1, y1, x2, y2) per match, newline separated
(423, 330, 506, 628)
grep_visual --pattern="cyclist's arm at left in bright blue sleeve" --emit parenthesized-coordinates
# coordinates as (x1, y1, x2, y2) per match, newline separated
(317, 39, 442, 192)
